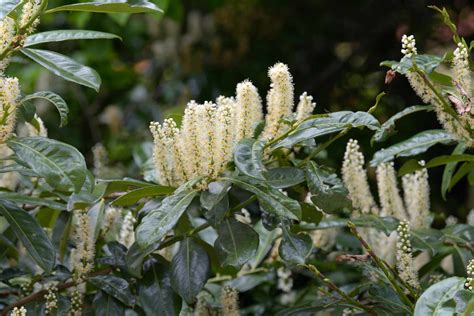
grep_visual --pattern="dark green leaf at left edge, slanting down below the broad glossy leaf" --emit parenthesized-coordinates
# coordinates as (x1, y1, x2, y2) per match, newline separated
(0, 199, 56, 273)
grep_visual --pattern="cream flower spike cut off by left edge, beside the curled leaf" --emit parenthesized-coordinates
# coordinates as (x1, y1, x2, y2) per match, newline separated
(0, 76, 20, 143)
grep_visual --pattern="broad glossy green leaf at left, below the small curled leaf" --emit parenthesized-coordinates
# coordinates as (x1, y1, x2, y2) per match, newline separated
(7, 137, 87, 191)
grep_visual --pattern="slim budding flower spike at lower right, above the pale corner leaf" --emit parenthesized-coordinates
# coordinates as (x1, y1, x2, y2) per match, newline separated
(397, 221, 420, 289)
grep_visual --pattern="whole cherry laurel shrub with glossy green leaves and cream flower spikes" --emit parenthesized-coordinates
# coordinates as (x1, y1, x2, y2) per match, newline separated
(0, 0, 474, 316)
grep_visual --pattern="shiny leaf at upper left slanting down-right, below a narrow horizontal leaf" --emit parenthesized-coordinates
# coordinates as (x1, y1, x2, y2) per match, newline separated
(21, 48, 101, 91)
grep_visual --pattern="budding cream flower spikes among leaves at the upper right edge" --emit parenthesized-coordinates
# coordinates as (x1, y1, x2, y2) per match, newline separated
(402, 35, 474, 146)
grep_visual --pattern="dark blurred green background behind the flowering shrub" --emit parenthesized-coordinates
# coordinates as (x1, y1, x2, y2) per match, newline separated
(3, 0, 474, 222)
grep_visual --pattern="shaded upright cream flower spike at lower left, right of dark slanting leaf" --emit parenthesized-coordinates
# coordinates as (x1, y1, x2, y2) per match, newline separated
(71, 210, 95, 284)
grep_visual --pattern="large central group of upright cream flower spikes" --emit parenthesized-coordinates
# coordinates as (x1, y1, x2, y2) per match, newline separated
(150, 63, 315, 187)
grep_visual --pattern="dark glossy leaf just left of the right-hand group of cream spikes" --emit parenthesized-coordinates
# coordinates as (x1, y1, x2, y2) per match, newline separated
(306, 161, 351, 213)
